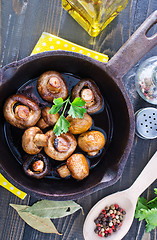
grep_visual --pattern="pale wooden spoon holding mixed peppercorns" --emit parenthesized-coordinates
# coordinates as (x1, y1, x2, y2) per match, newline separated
(83, 152, 157, 240)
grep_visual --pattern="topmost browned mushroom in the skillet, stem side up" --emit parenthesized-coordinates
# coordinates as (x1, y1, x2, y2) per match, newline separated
(37, 71, 68, 102)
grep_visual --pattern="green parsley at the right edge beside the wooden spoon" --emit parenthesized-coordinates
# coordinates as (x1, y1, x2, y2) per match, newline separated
(135, 188, 157, 232)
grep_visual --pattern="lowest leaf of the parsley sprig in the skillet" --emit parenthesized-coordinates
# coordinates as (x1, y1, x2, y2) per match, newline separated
(53, 115, 70, 136)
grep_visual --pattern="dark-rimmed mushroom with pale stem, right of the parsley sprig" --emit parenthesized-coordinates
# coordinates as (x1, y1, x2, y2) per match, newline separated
(72, 79, 103, 113)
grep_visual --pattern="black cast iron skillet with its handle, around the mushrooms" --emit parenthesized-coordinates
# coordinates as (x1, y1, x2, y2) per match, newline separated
(0, 11, 157, 200)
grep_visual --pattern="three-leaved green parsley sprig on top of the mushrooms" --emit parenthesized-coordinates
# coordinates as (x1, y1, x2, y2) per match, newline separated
(48, 96, 86, 136)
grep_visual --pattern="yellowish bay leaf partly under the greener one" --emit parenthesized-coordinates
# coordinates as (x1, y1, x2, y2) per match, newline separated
(10, 204, 62, 235)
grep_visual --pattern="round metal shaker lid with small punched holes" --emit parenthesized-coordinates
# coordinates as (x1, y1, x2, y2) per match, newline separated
(135, 107, 157, 139)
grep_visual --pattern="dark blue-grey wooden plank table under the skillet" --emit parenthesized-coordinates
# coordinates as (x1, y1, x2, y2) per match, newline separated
(0, 0, 157, 240)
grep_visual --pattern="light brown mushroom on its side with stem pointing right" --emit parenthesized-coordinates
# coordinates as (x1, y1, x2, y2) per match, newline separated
(22, 127, 48, 154)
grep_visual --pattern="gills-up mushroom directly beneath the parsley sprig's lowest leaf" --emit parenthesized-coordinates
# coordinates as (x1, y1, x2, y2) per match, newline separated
(44, 130, 77, 161)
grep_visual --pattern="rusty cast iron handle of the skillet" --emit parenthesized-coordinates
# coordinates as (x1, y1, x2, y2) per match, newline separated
(107, 10, 157, 78)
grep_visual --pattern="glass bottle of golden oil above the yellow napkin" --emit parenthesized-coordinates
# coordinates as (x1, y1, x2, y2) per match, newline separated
(62, 0, 129, 37)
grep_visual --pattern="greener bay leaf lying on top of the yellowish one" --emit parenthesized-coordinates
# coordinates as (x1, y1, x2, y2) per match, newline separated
(23, 200, 83, 219)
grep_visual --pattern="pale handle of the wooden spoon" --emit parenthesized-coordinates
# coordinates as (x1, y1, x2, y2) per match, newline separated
(129, 151, 157, 199)
